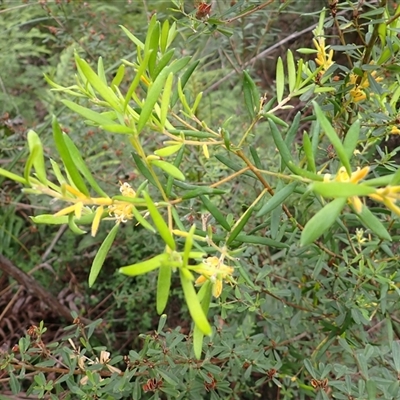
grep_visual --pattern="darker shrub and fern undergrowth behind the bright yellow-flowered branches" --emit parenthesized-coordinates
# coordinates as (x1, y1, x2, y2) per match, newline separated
(0, 0, 400, 400)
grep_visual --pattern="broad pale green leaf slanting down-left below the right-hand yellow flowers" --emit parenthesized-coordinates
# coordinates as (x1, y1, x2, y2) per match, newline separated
(300, 197, 347, 246)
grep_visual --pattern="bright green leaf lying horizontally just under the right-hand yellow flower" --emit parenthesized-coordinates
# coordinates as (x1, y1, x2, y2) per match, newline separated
(310, 182, 376, 198)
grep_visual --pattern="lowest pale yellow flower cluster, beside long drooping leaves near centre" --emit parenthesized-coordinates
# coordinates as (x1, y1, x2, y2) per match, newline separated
(194, 256, 233, 298)
